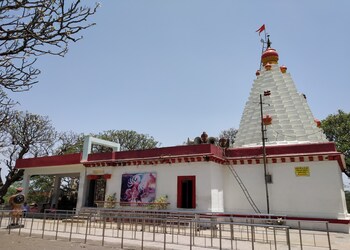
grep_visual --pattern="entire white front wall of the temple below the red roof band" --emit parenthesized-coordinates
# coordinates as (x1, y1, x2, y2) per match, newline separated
(21, 158, 348, 219)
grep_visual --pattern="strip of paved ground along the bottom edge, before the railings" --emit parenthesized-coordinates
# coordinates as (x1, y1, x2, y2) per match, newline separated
(0, 228, 350, 250)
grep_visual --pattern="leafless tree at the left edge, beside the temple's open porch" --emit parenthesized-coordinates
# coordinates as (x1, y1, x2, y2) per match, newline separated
(0, 111, 56, 203)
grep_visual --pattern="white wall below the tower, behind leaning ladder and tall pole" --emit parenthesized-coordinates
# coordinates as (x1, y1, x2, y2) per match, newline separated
(224, 161, 347, 219)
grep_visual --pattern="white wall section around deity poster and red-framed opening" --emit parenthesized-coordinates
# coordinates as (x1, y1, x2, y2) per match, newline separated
(106, 162, 223, 211)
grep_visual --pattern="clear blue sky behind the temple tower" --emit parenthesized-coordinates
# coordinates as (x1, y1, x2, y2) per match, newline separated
(7, 0, 350, 146)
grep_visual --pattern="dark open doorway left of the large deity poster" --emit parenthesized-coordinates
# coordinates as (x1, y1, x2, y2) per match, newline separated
(88, 177, 106, 207)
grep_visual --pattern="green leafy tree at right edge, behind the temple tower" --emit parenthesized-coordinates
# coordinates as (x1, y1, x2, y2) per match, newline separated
(321, 110, 350, 174)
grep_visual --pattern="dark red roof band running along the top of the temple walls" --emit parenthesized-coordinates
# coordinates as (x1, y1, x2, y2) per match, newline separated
(16, 142, 345, 171)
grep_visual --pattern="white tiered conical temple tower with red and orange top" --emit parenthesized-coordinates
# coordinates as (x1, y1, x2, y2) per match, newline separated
(234, 47, 327, 147)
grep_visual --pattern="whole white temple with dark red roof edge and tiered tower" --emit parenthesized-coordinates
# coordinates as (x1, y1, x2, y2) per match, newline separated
(16, 38, 350, 233)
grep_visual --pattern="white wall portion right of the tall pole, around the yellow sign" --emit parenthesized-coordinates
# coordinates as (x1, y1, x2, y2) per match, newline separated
(269, 161, 347, 218)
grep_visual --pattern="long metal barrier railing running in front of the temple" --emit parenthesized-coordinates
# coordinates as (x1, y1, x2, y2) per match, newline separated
(0, 209, 331, 250)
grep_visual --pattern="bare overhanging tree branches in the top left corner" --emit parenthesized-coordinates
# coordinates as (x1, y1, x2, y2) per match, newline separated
(0, 0, 98, 99)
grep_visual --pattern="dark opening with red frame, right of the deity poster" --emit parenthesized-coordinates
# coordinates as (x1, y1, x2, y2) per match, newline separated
(177, 176, 196, 208)
